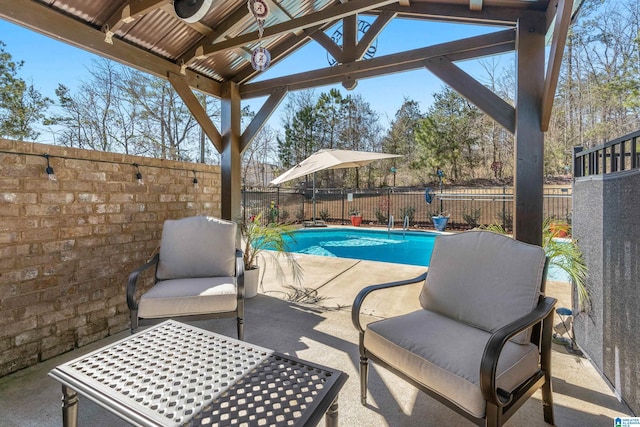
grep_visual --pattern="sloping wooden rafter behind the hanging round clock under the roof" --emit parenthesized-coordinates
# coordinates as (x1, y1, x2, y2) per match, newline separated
(203, 0, 398, 55)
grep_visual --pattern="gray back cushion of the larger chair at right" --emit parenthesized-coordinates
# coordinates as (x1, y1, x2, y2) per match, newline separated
(420, 231, 545, 342)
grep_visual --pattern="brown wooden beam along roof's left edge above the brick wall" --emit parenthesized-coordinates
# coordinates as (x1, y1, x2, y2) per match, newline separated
(0, 0, 220, 97)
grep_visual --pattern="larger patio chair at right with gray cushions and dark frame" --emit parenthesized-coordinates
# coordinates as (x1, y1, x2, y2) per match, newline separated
(352, 231, 556, 426)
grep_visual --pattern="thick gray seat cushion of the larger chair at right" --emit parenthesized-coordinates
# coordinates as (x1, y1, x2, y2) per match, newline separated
(364, 310, 538, 417)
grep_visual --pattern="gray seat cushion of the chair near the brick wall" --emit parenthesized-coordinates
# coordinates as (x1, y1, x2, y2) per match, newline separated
(138, 277, 237, 318)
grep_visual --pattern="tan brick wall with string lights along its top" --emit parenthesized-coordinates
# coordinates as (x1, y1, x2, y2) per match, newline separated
(0, 139, 220, 376)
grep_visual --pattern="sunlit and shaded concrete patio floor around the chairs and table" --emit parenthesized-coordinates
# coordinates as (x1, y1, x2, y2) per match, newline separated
(0, 255, 632, 427)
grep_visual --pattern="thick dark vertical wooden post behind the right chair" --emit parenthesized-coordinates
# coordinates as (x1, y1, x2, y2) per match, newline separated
(513, 12, 546, 245)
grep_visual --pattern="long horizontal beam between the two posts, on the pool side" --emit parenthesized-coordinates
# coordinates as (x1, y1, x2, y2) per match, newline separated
(241, 30, 515, 99)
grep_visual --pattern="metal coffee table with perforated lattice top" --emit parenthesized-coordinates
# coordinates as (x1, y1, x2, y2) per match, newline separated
(49, 320, 347, 427)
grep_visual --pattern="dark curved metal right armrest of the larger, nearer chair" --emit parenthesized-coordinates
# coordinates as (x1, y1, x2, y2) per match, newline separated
(480, 297, 557, 407)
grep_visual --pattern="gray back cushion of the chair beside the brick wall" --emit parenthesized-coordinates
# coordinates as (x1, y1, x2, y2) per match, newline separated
(156, 216, 237, 280)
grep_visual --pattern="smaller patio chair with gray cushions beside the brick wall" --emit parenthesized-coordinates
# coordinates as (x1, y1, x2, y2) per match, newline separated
(127, 216, 244, 339)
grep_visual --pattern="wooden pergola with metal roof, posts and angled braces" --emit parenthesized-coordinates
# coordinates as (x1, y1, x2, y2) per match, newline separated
(0, 0, 580, 244)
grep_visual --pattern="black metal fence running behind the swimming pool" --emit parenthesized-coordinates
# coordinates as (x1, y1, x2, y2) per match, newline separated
(242, 187, 572, 230)
